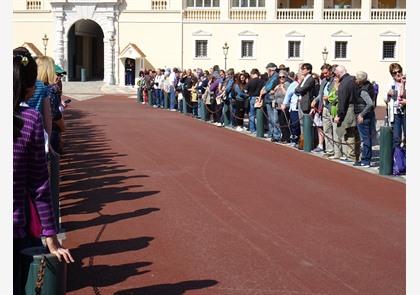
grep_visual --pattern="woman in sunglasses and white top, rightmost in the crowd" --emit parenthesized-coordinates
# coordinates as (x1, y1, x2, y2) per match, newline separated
(385, 63, 406, 148)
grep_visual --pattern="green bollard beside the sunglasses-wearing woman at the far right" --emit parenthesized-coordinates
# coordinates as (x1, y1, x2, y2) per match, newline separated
(379, 126, 393, 175)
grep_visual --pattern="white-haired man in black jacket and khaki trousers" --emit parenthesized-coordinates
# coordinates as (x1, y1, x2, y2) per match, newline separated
(334, 65, 360, 165)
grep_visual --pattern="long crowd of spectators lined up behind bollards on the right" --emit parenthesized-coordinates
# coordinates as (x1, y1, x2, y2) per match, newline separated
(137, 63, 406, 167)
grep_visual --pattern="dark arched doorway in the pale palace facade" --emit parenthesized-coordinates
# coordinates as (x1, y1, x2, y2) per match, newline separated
(67, 19, 104, 81)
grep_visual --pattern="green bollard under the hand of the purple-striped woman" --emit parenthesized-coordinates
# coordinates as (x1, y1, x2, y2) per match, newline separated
(21, 247, 67, 295)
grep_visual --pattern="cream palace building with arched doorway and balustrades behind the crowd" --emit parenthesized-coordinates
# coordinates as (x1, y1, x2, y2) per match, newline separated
(12, 0, 406, 103)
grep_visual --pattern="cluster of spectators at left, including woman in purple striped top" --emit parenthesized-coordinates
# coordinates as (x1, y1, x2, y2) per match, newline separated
(13, 47, 74, 295)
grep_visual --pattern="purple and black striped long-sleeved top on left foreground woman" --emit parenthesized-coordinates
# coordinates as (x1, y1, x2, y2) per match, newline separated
(13, 107, 57, 238)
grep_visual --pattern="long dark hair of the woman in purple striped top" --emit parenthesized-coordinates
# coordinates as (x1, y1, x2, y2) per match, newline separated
(13, 47, 37, 140)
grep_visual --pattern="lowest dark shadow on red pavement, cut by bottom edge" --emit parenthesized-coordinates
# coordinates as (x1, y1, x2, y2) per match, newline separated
(114, 280, 218, 295)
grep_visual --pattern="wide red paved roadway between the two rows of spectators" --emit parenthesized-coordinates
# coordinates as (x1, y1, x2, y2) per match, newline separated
(61, 96, 405, 295)
